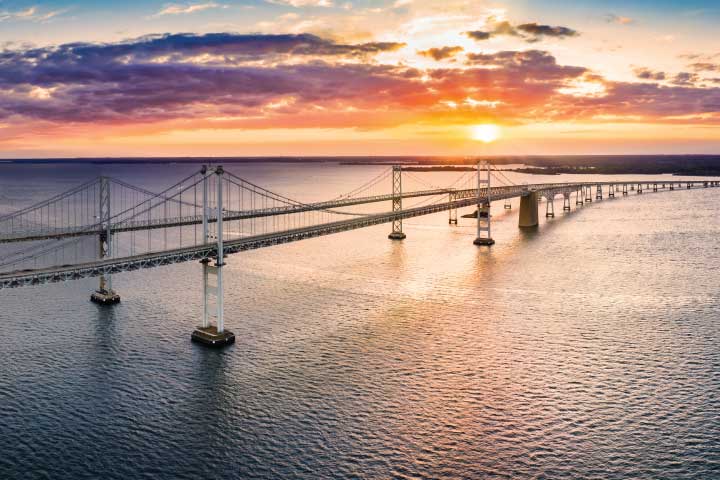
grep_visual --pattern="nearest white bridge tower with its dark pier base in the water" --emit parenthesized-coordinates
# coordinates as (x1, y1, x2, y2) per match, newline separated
(190, 166, 235, 347)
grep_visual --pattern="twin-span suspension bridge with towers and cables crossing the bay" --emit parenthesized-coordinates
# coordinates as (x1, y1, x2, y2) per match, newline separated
(0, 164, 720, 346)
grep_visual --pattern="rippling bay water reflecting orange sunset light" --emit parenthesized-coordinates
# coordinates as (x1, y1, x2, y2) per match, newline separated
(0, 164, 720, 479)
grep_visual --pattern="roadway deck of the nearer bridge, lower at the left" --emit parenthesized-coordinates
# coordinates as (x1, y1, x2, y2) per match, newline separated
(0, 181, 703, 289)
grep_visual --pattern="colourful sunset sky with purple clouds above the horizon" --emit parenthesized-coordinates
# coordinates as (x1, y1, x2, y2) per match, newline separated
(0, 0, 720, 158)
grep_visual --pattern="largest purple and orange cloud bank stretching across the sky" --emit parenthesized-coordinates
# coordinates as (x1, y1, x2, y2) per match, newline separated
(0, 33, 720, 132)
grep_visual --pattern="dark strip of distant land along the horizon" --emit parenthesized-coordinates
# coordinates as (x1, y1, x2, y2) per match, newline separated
(0, 155, 720, 176)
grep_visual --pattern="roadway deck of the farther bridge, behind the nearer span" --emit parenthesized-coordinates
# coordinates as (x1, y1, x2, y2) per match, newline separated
(0, 180, 703, 243)
